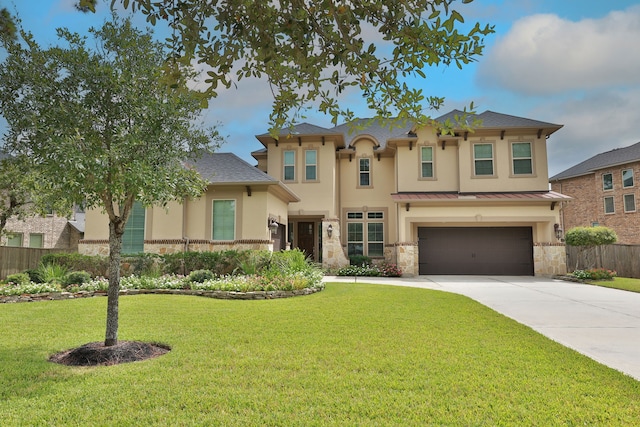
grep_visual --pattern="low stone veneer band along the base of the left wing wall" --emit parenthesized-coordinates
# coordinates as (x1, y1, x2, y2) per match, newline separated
(78, 239, 273, 256)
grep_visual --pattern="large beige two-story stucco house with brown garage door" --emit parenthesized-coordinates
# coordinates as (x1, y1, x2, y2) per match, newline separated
(80, 110, 568, 276)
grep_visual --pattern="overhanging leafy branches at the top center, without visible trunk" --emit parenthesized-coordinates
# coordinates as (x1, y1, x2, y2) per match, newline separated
(100, 0, 493, 132)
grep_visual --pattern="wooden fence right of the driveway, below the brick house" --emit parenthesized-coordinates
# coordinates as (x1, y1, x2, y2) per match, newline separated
(567, 245, 640, 279)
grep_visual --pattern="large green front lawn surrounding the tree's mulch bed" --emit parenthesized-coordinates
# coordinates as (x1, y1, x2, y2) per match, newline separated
(0, 284, 640, 426)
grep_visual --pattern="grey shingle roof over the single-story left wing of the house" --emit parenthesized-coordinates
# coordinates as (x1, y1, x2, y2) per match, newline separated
(185, 153, 278, 184)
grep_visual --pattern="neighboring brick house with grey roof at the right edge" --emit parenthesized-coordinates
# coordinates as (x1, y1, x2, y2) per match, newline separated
(549, 142, 640, 244)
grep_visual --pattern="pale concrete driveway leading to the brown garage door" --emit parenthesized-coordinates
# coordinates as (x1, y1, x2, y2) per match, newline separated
(325, 276, 640, 380)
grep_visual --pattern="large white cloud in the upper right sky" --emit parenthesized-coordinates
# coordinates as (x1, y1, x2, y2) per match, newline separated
(478, 6, 640, 95)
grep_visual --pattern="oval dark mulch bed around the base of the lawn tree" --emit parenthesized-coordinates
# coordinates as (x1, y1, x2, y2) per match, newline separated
(49, 341, 171, 366)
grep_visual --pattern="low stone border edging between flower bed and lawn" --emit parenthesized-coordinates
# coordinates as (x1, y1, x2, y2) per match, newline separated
(0, 286, 324, 304)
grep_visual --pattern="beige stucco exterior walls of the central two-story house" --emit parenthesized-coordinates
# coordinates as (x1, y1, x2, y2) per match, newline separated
(81, 112, 567, 276)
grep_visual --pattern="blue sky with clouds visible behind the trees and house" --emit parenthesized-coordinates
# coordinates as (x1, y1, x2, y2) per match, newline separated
(0, 0, 640, 175)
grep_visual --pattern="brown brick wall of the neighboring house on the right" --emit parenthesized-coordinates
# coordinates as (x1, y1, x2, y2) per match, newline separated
(551, 162, 640, 244)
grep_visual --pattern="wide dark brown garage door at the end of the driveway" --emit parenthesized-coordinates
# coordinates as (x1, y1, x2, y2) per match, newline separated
(418, 227, 533, 276)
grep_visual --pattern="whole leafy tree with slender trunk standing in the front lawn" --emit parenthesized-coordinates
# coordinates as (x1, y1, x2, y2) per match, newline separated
(0, 16, 217, 346)
